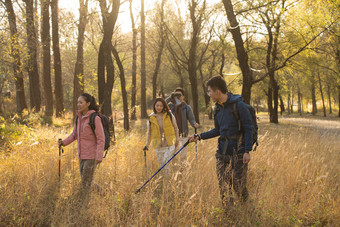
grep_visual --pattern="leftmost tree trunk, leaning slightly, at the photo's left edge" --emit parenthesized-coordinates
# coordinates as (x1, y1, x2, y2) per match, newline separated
(5, 0, 27, 114)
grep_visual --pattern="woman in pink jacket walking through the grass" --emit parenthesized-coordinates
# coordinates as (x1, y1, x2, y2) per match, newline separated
(59, 93, 105, 194)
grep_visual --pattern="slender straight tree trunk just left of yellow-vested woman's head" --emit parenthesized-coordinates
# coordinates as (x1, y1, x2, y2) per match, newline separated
(140, 0, 148, 119)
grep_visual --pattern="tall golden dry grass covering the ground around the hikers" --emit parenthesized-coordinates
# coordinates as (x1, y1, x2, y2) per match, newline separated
(0, 115, 340, 226)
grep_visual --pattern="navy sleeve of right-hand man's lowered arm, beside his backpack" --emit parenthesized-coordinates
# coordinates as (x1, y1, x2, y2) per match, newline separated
(237, 102, 253, 151)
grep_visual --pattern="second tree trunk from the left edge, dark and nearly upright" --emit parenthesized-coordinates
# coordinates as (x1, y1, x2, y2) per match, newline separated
(24, 0, 41, 112)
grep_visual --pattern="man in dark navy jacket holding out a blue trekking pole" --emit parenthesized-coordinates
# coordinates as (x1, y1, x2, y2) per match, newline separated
(189, 76, 253, 207)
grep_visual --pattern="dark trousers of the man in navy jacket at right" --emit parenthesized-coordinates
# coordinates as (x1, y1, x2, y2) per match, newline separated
(216, 153, 249, 206)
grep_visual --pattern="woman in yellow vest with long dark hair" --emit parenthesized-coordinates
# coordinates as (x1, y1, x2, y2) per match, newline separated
(143, 97, 179, 173)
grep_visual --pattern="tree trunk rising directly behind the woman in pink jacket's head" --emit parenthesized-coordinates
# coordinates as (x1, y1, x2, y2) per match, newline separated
(73, 0, 88, 117)
